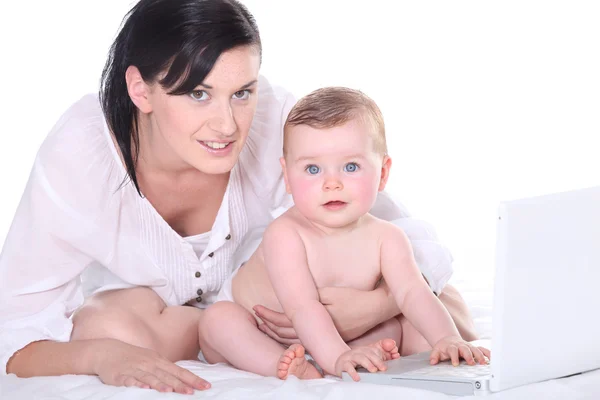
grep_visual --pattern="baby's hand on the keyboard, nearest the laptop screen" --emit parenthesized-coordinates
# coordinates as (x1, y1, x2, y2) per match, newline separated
(429, 336, 491, 367)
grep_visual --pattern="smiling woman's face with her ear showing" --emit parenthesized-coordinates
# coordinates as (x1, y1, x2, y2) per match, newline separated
(140, 46, 260, 174)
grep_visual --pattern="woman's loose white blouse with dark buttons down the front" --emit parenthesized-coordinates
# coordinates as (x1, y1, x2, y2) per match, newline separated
(0, 77, 452, 374)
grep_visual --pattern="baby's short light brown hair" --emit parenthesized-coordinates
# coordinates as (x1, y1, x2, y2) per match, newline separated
(283, 87, 387, 155)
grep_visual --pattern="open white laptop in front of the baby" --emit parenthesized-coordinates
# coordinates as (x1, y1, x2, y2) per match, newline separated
(343, 186, 600, 396)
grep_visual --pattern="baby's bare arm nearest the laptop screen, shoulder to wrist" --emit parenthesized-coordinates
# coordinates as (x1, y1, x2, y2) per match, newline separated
(381, 224, 460, 347)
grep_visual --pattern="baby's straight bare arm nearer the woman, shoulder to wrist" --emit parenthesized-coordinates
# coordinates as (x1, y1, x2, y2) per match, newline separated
(262, 219, 350, 374)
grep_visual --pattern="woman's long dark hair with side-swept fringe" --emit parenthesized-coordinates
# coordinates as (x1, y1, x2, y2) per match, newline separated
(100, 0, 261, 196)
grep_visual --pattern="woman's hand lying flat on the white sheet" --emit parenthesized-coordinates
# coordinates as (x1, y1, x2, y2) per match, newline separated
(93, 339, 210, 394)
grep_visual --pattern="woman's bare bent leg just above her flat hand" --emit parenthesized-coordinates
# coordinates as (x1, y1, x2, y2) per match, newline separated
(71, 287, 202, 362)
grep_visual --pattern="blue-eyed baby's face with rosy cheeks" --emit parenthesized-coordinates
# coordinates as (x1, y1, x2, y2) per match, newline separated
(284, 120, 389, 228)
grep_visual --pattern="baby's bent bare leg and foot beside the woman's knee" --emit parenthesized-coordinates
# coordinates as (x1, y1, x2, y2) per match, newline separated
(198, 301, 321, 379)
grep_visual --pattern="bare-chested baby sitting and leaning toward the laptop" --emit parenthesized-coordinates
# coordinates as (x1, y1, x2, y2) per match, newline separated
(199, 87, 489, 381)
